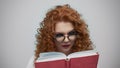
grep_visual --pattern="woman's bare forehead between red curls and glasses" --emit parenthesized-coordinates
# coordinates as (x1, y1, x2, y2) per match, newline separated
(55, 21, 74, 33)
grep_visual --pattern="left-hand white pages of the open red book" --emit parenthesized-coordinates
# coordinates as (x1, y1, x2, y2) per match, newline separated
(36, 52, 66, 62)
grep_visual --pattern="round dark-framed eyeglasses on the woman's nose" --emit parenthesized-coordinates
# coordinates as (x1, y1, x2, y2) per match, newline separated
(54, 30, 77, 42)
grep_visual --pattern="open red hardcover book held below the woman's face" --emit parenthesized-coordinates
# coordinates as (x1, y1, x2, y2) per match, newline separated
(35, 50, 99, 68)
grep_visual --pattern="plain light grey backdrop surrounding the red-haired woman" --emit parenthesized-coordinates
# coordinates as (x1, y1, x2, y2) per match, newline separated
(0, 0, 120, 68)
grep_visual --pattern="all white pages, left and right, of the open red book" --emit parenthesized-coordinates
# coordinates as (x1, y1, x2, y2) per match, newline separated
(36, 50, 97, 62)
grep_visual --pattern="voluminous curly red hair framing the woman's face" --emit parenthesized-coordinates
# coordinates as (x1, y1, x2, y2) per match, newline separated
(35, 4, 93, 60)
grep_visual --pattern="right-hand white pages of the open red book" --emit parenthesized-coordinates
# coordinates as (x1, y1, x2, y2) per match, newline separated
(67, 50, 97, 59)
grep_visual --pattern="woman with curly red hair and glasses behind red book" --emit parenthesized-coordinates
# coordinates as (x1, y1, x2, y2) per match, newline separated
(28, 5, 93, 68)
